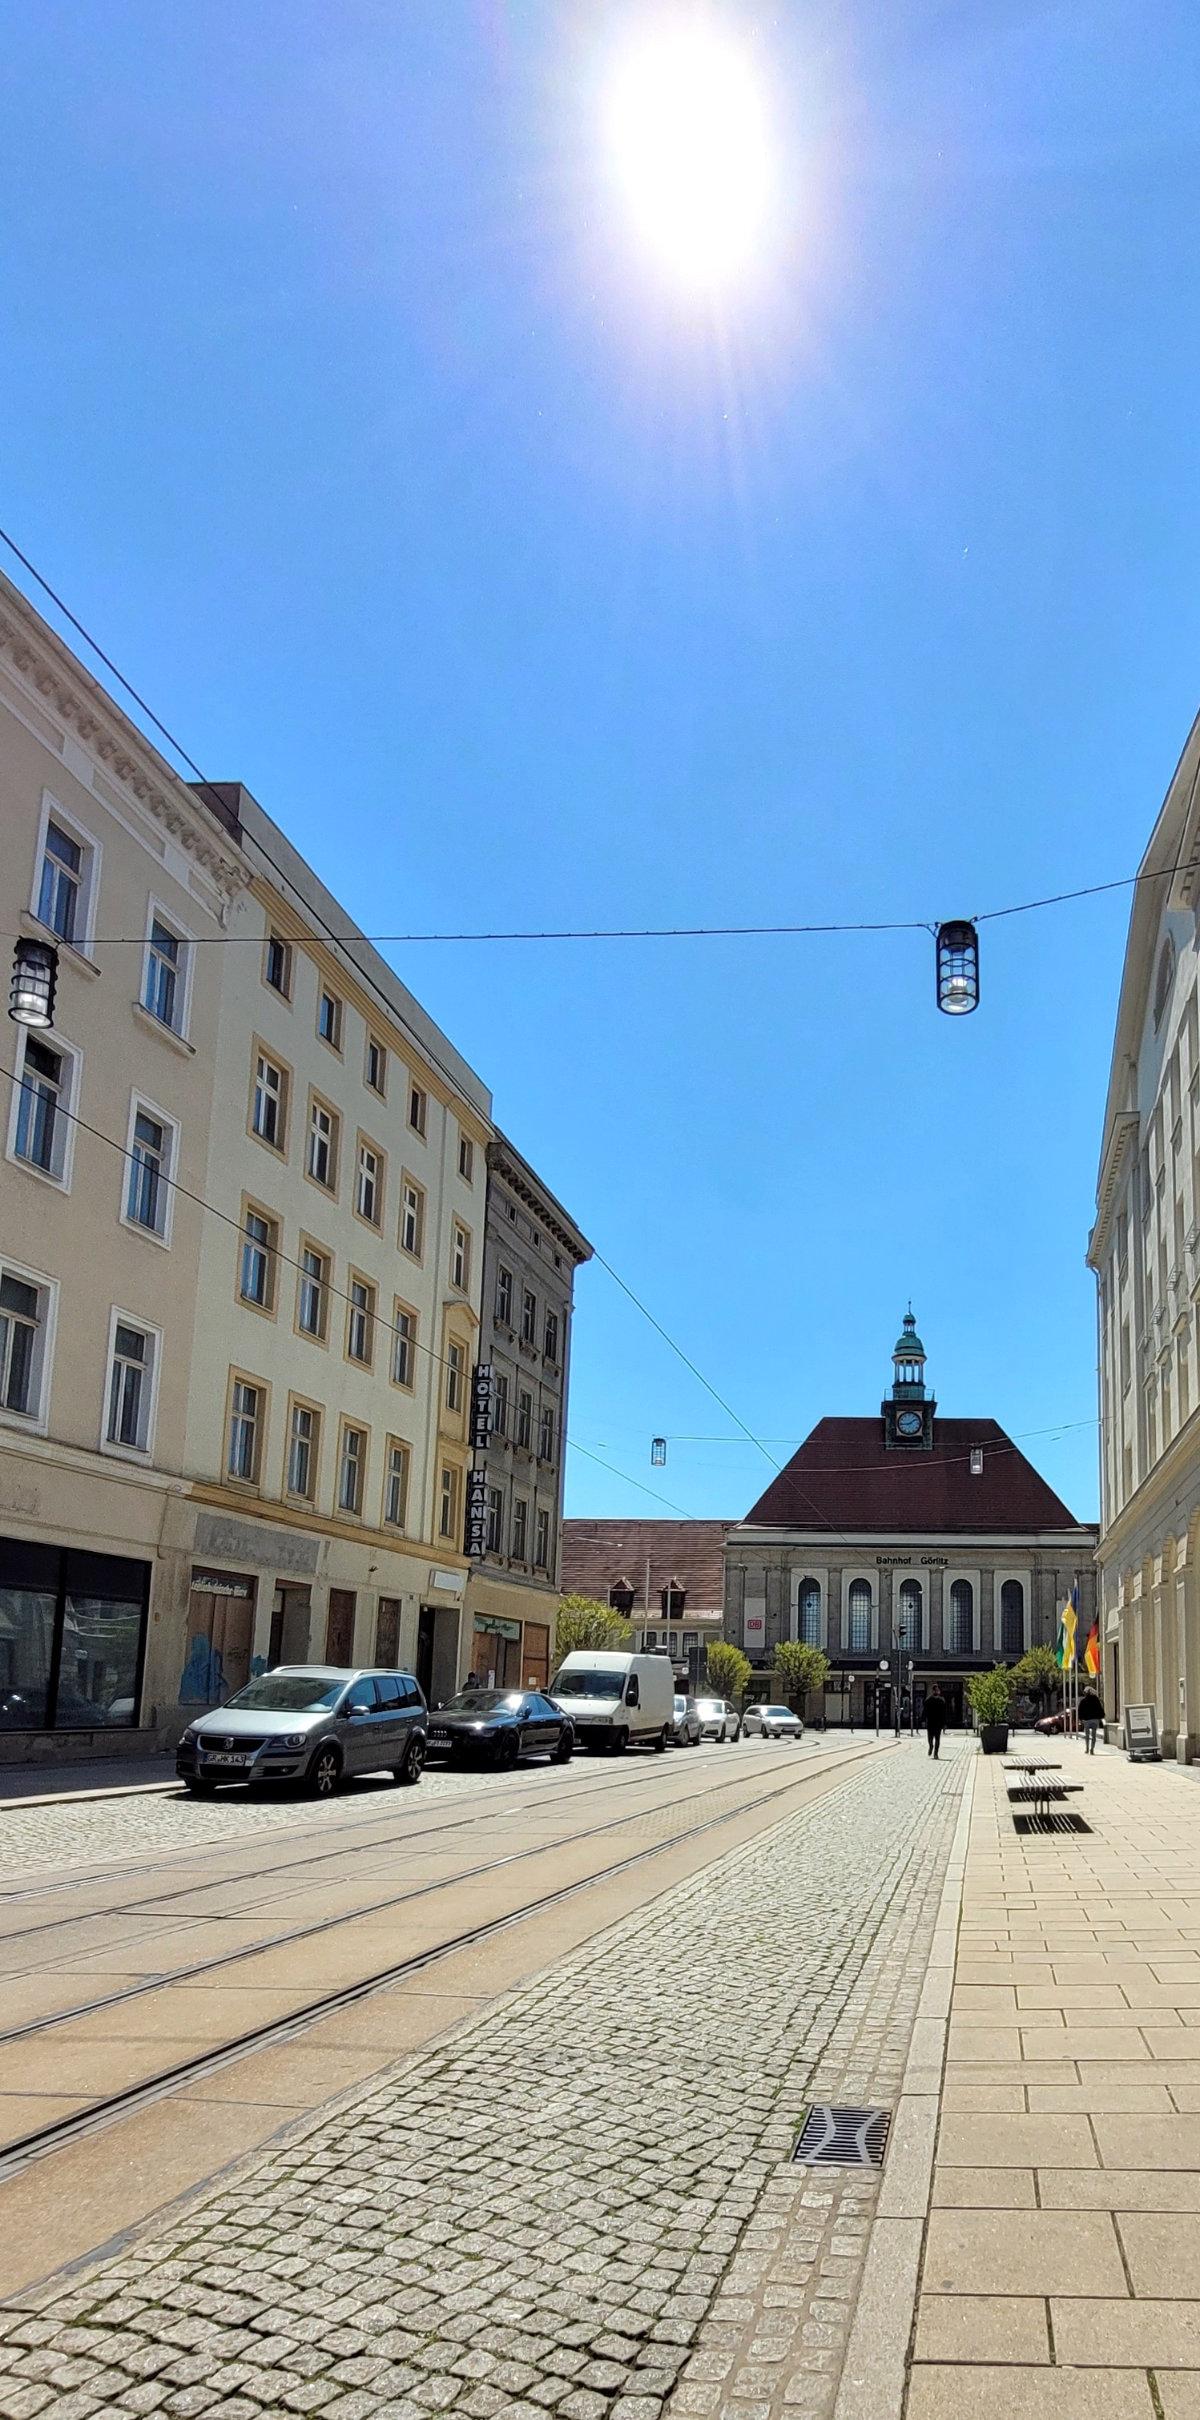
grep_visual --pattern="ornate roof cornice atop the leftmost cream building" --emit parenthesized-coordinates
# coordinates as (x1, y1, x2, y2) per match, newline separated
(0, 571, 249, 900)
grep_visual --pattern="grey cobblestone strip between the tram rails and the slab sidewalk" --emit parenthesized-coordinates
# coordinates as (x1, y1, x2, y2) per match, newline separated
(0, 1742, 970, 2420)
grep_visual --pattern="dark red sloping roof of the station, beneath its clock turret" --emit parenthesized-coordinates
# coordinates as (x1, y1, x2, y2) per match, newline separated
(745, 1421, 1084, 1537)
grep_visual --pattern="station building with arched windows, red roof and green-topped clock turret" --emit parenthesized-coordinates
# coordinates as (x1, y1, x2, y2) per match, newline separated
(726, 1312, 1096, 1723)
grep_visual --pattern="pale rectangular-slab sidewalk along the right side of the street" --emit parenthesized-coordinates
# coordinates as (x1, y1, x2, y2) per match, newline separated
(907, 1742, 1200, 2420)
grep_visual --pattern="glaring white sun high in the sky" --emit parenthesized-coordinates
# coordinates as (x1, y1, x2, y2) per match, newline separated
(605, 15, 772, 290)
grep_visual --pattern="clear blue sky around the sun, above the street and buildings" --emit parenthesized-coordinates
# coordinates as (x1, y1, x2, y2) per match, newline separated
(0, 0, 1200, 1515)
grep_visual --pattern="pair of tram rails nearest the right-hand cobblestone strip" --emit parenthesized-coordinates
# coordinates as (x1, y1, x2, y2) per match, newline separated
(0, 1752, 864, 2185)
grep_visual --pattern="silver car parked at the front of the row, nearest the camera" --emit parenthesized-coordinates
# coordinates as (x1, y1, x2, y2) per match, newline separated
(174, 1665, 428, 1798)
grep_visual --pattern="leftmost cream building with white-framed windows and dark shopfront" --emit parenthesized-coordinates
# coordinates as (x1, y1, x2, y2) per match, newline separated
(0, 578, 247, 1757)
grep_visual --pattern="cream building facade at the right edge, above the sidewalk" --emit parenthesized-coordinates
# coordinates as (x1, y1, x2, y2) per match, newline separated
(1089, 724, 1200, 1762)
